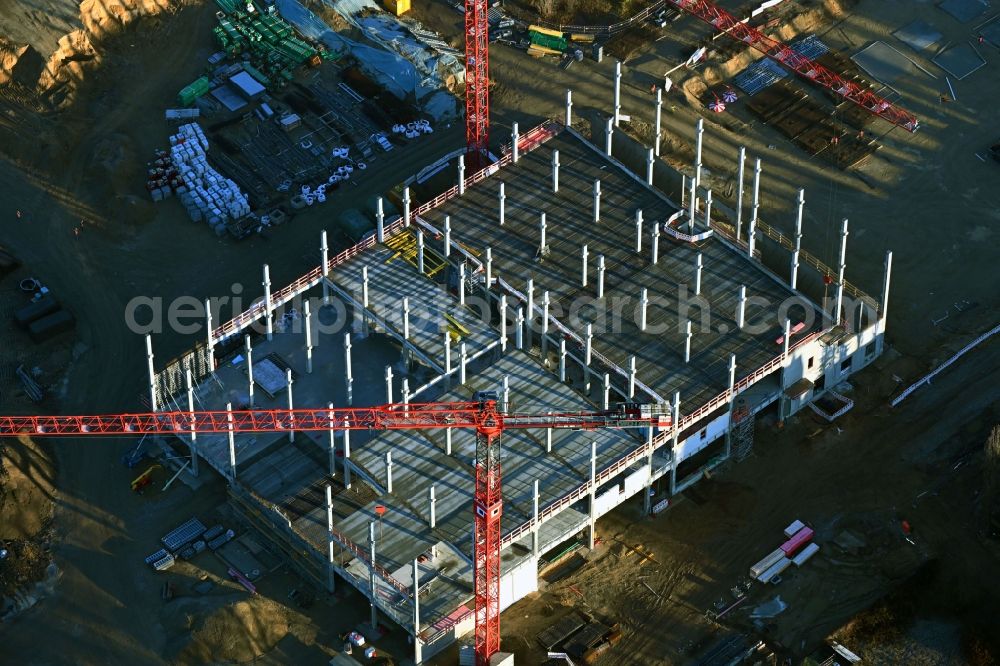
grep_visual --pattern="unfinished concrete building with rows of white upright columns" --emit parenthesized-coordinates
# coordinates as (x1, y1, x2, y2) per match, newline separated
(149, 96, 891, 663)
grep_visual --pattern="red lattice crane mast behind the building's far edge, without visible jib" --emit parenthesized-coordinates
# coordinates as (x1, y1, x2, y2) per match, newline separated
(465, 0, 490, 170)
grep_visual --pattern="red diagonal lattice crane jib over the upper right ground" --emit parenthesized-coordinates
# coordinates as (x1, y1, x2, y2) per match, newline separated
(667, 0, 920, 132)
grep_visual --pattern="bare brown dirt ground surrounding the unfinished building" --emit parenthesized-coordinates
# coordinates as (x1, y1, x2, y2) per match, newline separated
(0, 0, 1000, 664)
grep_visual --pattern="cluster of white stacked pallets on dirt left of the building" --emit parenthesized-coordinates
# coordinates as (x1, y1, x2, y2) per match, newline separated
(170, 123, 250, 236)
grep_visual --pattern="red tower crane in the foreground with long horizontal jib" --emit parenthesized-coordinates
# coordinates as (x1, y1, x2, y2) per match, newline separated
(0, 392, 670, 666)
